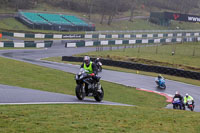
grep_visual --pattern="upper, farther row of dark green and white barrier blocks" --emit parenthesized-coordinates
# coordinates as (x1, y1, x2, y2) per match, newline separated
(2, 31, 200, 39)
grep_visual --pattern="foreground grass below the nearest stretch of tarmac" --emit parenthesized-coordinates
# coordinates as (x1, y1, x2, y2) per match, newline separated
(0, 105, 200, 133)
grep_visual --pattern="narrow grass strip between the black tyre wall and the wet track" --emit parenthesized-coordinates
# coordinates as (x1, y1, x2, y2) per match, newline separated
(44, 57, 200, 86)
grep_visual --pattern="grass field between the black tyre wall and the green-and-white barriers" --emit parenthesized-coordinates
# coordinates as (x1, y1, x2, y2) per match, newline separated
(77, 42, 200, 71)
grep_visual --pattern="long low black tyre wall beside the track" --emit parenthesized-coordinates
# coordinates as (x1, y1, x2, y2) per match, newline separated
(62, 56, 200, 80)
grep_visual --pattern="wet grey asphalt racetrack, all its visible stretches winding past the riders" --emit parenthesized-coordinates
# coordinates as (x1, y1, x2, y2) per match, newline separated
(0, 41, 200, 112)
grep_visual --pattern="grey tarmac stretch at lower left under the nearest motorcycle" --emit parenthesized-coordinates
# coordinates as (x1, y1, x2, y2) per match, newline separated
(0, 85, 129, 106)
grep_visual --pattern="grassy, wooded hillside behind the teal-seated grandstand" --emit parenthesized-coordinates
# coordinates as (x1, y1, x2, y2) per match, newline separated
(0, 0, 200, 33)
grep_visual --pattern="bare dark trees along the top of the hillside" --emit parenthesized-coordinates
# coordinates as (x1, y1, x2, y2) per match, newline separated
(0, 0, 200, 25)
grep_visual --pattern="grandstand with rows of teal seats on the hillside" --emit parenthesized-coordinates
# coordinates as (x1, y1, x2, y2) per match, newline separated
(18, 11, 95, 31)
